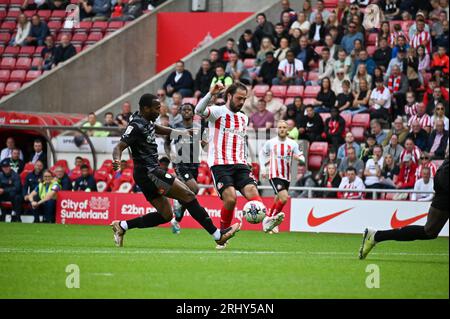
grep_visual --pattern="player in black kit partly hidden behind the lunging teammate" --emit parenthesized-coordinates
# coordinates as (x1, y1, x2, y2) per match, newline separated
(168, 103, 201, 234)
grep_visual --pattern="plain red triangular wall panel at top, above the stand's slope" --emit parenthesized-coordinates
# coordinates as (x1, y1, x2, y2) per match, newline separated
(156, 12, 252, 72)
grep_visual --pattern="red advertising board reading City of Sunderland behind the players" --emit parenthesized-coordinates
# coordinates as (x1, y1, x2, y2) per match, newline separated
(56, 192, 291, 231)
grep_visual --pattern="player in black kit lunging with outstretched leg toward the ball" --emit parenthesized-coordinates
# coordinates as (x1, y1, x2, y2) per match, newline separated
(111, 94, 241, 247)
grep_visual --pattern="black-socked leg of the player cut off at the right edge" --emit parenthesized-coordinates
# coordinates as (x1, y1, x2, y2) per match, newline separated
(359, 157, 449, 259)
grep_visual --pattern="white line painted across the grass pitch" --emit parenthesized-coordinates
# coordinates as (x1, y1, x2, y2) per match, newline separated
(0, 247, 449, 257)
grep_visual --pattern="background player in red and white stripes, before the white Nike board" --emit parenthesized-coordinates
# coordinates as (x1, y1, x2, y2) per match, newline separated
(259, 121, 305, 232)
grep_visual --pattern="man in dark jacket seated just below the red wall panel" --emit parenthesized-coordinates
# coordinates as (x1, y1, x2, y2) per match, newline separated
(163, 60, 194, 97)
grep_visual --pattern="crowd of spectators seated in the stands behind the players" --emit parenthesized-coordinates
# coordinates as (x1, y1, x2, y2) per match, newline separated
(0, 0, 449, 224)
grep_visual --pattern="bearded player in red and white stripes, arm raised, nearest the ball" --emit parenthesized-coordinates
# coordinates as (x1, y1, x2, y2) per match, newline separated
(195, 83, 282, 249)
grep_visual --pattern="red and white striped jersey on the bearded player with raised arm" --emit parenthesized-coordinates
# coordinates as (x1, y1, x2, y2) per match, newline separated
(205, 105, 248, 167)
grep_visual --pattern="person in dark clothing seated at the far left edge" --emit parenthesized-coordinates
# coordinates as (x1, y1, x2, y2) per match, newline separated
(0, 158, 23, 222)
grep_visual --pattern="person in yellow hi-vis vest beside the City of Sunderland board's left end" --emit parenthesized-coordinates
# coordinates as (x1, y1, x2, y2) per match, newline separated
(26, 170, 61, 223)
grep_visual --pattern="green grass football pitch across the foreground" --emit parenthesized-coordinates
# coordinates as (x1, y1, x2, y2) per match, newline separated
(0, 223, 449, 298)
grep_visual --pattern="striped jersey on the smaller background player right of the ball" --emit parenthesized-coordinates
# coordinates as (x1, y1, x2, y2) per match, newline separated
(260, 136, 302, 182)
